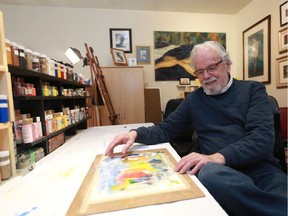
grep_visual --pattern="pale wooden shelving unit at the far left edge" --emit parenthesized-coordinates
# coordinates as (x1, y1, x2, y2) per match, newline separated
(0, 11, 16, 183)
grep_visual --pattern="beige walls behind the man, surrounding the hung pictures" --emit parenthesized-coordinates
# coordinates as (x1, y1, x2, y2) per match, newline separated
(0, 0, 287, 109)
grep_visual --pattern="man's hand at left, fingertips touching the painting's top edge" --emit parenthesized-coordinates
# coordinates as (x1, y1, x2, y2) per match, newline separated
(105, 130, 137, 157)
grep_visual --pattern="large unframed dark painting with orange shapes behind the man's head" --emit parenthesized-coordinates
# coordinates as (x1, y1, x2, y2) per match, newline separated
(154, 31, 226, 81)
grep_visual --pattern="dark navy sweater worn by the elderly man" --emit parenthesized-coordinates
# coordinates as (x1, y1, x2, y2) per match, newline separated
(136, 79, 277, 168)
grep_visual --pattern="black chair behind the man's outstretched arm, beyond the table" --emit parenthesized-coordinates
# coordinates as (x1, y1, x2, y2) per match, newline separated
(163, 99, 199, 157)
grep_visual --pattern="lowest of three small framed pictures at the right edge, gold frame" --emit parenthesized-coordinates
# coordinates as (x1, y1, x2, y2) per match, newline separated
(276, 55, 288, 88)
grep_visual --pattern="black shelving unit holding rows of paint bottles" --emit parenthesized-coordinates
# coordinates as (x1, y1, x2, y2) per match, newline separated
(8, 65, 90, 155)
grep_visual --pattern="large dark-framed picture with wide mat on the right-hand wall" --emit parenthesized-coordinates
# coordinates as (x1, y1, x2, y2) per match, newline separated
(243, 15, 271, 84)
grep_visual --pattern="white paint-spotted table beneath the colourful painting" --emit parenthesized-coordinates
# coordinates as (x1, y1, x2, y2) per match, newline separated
(0, 123, 227, 216)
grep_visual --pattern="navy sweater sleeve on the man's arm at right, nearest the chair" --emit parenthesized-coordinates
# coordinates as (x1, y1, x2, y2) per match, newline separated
(219, 83, 274, 167)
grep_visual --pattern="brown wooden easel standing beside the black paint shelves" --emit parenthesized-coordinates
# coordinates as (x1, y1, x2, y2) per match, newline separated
(84, 43, 119, 125)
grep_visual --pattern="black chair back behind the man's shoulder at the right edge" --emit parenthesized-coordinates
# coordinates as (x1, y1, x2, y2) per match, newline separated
(268, 95, 287, 173)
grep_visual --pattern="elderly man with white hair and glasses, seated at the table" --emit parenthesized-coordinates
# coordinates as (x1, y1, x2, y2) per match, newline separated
(106, 41, 287, 216)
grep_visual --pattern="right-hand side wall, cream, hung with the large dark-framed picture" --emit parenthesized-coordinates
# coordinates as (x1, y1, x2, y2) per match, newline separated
(235, 0, 287, 107)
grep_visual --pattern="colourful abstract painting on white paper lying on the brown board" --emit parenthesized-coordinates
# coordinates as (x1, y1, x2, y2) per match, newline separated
(91, 151, 186, 201)
